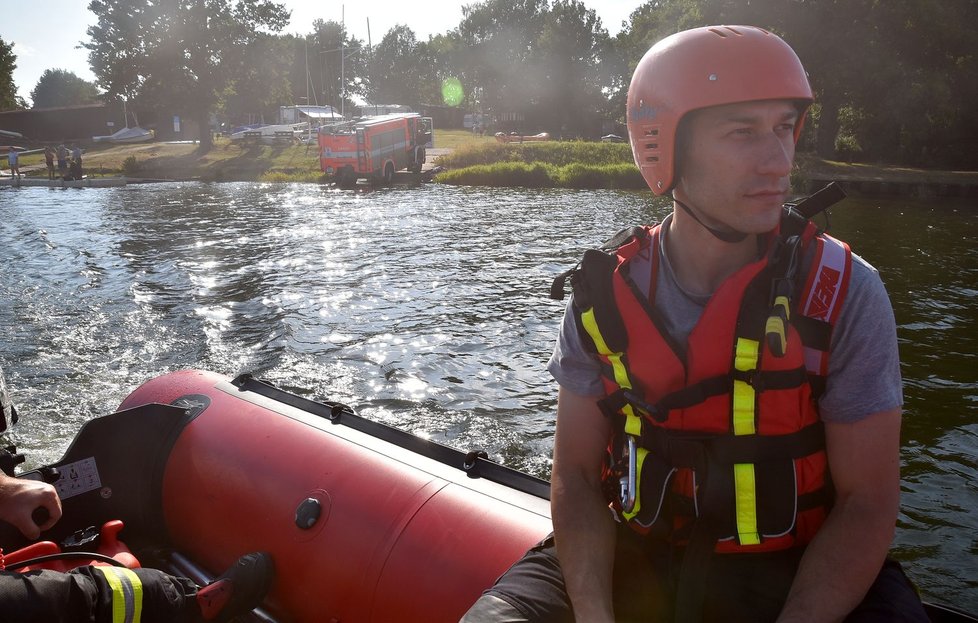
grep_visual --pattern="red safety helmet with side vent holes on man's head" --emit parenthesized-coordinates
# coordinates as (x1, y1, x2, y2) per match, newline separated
(627, 26, 812, 195)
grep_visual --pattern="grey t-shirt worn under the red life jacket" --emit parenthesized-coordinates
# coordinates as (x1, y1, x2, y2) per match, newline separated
(547, 217, 903, 423)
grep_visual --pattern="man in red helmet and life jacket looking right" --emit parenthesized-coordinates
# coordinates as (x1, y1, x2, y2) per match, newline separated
(463, 26, 928, 623)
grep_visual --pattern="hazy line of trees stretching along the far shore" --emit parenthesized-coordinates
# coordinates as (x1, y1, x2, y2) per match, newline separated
(0, 0, 978, 168)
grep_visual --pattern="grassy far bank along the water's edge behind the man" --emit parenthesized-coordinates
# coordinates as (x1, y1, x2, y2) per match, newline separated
(11, 129, 978, 190)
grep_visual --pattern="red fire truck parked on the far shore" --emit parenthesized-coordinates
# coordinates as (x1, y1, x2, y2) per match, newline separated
(319, 113, 431, 185)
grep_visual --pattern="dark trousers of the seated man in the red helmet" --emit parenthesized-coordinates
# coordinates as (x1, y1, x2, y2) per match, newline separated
(463, 529, 930, 623)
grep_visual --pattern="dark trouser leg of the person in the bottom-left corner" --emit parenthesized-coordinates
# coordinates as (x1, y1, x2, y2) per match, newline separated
(0, 567, 200, 623)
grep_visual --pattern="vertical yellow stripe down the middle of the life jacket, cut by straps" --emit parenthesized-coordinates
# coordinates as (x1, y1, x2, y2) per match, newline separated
(731, 337, 761, 545)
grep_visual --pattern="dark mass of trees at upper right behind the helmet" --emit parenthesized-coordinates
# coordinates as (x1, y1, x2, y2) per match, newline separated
(616, 0, 978, 166)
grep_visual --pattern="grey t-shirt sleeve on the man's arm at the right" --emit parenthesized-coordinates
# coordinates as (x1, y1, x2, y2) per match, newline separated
(819, 254, 903, 423)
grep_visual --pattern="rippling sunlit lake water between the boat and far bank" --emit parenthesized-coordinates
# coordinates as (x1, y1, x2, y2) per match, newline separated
(0, 183, 978, 611)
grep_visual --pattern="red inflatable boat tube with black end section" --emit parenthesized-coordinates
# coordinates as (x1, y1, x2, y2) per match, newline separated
(0, 371, 550, 623)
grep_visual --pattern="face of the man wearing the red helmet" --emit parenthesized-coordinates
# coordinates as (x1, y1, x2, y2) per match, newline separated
(675, 100, 799, 234)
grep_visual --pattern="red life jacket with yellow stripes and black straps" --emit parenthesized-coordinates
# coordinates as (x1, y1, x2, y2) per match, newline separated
(572, 216, 851, 553)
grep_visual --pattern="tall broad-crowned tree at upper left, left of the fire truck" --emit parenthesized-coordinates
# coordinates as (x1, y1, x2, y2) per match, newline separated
(83, 0, 289, 150)
